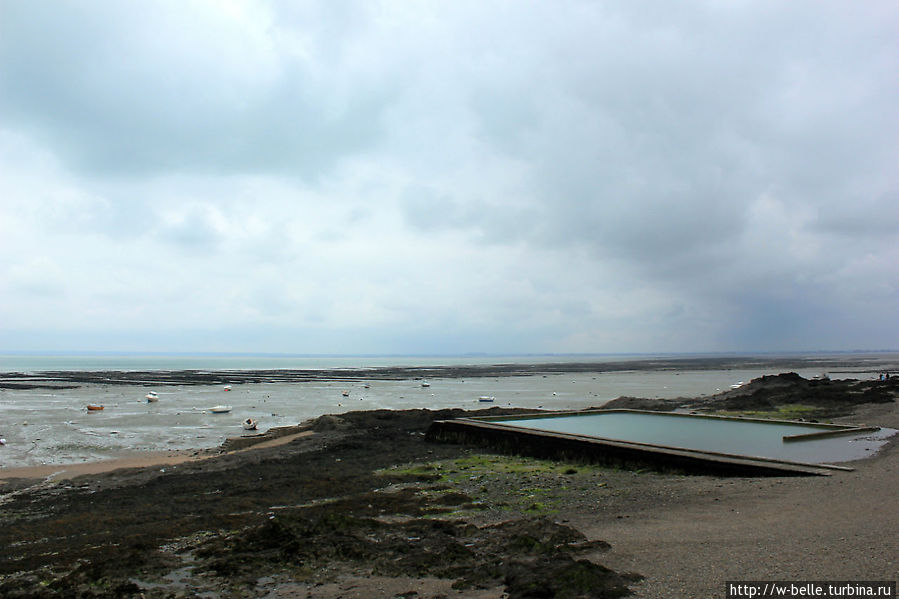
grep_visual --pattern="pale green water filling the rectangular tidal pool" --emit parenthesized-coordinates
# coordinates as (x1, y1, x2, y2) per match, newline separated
(486, 410, 896, 464)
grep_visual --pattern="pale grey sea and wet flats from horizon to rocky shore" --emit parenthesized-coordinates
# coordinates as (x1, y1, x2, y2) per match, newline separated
(0, 353, 899, 469)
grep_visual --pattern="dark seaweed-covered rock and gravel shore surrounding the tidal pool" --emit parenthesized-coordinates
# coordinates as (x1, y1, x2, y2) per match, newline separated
(0, 374, 899, 598)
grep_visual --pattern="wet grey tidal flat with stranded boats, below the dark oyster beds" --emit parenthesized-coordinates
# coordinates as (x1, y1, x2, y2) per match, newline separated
(0, 354, 899, 468)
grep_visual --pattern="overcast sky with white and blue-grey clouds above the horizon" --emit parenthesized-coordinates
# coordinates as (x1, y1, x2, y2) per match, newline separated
(0, 0, 899, 354)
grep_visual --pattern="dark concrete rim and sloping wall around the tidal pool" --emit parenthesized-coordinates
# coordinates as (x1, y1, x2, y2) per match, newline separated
(427, 409, 879, 476)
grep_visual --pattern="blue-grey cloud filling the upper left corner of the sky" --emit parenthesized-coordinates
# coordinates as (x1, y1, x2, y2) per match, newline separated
(0, 3, 390, 178)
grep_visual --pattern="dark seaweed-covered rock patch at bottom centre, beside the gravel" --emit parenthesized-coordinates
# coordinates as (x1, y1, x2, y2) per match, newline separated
(196, 509, 638, 597)
